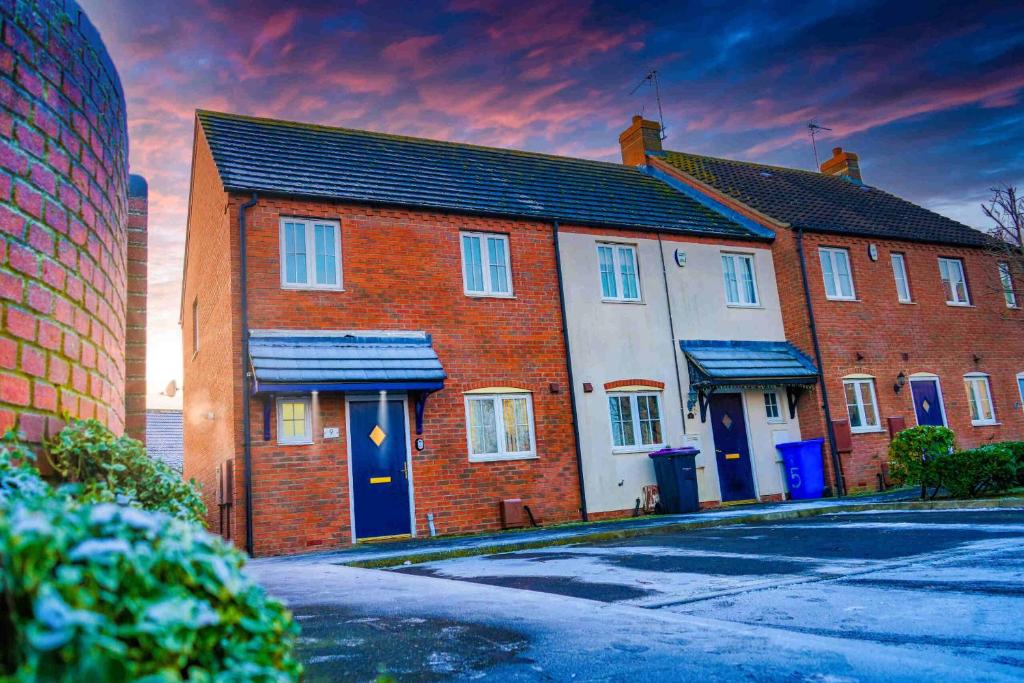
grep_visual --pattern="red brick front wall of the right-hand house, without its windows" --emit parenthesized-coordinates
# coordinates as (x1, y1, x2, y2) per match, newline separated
(775, 233, 1024, 490)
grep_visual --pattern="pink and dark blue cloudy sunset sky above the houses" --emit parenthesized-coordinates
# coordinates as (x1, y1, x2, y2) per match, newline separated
(80, 0, 1024, 407)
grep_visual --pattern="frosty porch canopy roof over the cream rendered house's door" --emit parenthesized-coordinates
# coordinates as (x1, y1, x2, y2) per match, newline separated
(679, 340, 818, 386)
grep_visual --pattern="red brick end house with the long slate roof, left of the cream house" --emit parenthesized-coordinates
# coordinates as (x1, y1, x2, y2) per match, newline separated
(181, 112, 806, 555)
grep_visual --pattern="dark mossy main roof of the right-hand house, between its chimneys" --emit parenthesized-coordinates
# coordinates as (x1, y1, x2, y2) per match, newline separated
(663, 152, 989, 247)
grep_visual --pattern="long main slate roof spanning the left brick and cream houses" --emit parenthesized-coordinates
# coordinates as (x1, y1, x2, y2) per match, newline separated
(197, 111, 766, 240)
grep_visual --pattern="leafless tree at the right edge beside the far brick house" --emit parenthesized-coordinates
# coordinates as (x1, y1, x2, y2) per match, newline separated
(981, 185, 1024, 317)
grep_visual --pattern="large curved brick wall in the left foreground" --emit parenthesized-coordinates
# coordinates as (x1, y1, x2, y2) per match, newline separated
(0, 0, 128, 441)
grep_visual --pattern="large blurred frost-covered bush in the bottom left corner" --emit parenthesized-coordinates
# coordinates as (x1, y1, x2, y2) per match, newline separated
(0, 496, 300, 681)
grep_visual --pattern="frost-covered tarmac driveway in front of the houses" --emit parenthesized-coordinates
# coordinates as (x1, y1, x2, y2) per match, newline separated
(251, 509, 1024, 681)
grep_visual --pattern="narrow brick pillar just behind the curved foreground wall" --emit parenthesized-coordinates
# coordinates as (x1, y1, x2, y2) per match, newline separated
(125, 175, 150, 443)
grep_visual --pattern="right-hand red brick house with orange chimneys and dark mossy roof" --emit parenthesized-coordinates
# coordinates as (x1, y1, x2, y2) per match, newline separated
(627, 122, 1024, 492)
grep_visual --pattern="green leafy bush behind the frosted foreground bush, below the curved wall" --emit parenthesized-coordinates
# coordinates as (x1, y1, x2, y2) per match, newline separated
(47, 420, 206, 524)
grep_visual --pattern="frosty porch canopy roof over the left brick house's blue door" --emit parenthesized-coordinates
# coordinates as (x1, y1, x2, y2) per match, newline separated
(249, 330, 446, 391)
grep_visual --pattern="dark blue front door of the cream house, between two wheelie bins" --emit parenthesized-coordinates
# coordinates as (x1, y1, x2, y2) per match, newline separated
(711, 393, 755, 503)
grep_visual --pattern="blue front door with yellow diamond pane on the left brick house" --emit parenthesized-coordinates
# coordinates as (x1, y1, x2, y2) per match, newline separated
(348, 400, 411, 539)
